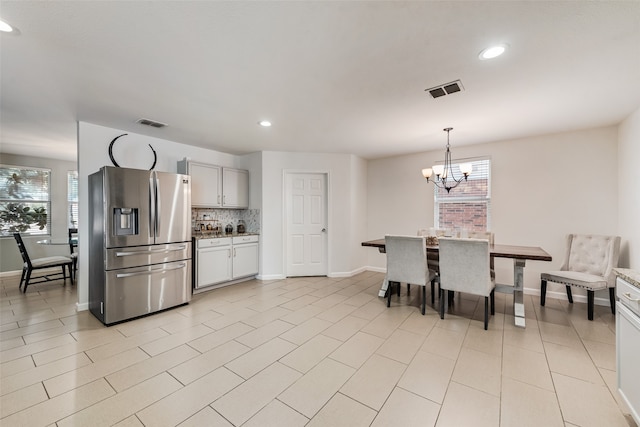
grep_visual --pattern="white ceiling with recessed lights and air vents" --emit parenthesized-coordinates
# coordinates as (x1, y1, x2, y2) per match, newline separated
(0, 0, 640, 159)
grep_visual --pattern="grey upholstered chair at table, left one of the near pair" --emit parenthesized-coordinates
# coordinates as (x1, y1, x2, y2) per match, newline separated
(385, 236, 436, 314)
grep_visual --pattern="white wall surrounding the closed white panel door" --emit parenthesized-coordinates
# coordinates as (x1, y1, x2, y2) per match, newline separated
(260, 151, 366, 279)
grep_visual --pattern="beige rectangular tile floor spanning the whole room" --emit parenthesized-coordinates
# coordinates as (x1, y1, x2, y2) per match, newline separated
(0, 272, 635, 427)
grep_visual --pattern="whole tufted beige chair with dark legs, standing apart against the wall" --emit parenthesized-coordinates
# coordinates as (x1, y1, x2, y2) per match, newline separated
(540, 234, 620, 320)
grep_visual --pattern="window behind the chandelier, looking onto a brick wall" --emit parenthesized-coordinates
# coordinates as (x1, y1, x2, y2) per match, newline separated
(434, 158, 491, 231)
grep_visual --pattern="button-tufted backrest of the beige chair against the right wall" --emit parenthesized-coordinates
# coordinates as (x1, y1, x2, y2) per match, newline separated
(560, 234, 620, 287)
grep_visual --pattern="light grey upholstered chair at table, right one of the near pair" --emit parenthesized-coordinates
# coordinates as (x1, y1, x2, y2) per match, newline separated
(438, 237, 496, 330)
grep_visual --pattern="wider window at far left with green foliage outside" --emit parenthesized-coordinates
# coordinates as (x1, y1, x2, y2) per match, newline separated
(0, 165, 51, 236)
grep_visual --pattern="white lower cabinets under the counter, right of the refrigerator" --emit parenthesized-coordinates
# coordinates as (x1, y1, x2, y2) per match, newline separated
(195, 235, 259, 289)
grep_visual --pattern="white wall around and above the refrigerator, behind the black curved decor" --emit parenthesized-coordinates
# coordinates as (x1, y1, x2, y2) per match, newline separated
(78, 122, 252, 310)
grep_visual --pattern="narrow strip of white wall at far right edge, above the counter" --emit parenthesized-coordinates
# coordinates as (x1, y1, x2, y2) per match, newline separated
(618, 108, 640, 270)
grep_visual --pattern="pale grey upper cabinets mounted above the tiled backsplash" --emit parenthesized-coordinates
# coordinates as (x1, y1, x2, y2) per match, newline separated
(178, 159, 249, 209)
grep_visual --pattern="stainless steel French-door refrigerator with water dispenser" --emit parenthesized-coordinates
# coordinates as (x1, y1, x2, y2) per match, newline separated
(89, 166, 192, 325)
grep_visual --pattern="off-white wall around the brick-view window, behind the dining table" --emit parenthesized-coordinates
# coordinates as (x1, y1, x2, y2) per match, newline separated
(367, 127, 618, 304)
